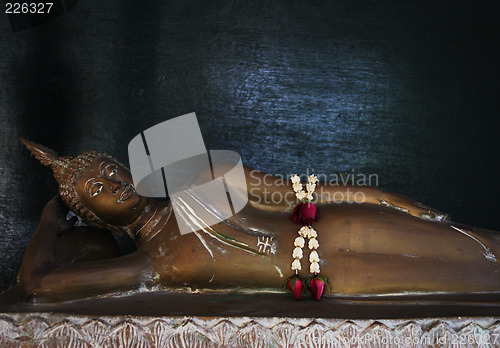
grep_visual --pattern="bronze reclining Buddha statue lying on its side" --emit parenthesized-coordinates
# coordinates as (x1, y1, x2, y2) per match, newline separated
(9, 139, 500, 301)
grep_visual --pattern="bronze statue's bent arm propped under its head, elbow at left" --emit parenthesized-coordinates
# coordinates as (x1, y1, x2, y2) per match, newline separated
(18, 197, 151, 300)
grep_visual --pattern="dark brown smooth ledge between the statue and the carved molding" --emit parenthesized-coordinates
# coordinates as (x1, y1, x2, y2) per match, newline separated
(0, 291, 500, 319)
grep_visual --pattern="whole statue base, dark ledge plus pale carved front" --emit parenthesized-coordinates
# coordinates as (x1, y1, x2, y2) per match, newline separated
(0, 292, 500, 347)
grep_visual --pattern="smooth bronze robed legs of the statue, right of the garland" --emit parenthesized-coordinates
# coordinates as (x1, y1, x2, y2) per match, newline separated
(315, 204, 500, 295)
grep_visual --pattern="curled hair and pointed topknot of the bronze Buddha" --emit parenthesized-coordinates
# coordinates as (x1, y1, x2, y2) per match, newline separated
(20, 138, 113, 228)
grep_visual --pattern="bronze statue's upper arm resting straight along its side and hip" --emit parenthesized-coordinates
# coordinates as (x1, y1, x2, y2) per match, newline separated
(245, 167, 449, 221)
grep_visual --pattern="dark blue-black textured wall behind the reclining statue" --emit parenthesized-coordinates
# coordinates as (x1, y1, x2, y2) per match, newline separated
(0, 0, 500, 289)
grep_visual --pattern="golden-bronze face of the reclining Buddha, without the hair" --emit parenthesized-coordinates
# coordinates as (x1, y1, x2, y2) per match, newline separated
(76, 157, 147, 226)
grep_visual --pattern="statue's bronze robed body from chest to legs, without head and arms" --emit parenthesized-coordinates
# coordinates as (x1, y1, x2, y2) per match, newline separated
(141, 204, 500, 295)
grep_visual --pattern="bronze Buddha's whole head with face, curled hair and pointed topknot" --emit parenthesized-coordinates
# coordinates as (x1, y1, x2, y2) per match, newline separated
(21, 139, 147, 231)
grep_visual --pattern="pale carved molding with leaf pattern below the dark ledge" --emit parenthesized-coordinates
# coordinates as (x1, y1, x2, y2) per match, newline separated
(0, 313, 500, 348)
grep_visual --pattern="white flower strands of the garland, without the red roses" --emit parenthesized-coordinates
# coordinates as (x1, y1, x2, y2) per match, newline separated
(290, 174, 320, 274)
